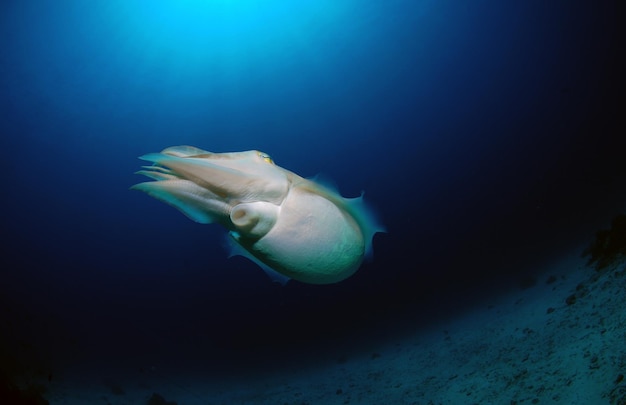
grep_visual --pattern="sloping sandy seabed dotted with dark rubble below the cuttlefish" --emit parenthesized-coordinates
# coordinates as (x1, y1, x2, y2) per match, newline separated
(25, 254, 626, 405)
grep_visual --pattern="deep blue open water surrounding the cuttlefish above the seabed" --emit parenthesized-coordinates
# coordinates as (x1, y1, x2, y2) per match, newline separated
(0, 0, 626, 400)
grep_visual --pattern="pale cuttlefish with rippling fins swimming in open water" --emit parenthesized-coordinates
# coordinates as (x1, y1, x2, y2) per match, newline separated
(131, 146, 384, 284)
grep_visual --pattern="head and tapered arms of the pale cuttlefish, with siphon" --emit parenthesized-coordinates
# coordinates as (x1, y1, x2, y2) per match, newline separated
(131, 146, 289, 237)
